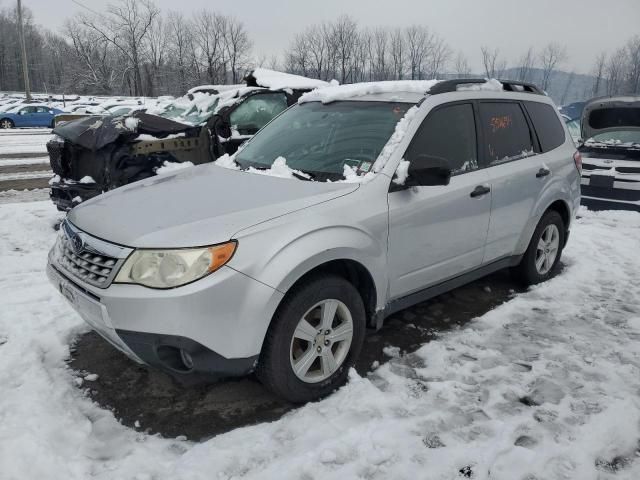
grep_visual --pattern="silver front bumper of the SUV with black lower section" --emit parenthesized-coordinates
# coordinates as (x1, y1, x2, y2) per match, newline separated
(47, 249, 282, 380)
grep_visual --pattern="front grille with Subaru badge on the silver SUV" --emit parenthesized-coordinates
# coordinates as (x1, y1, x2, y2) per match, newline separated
(55, 220, 131, 288)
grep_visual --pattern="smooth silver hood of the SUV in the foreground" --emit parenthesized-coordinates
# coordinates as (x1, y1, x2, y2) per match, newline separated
(68, 163, 358, 248)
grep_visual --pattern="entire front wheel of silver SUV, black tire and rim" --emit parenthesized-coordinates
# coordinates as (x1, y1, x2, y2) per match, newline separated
(256, 274, 366, 403)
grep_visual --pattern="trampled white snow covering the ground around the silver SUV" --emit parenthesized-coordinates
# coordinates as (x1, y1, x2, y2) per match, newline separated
(0, 202, 640, 480)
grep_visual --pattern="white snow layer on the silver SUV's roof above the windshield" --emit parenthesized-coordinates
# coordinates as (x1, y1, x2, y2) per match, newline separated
(298, 80, 440, 103)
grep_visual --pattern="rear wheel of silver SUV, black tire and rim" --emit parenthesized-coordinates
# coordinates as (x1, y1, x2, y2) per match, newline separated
(512, 210, 566, 286)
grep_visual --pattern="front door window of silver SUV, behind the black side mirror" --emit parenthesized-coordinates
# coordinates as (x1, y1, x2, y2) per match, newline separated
(404, 103, 478, 175)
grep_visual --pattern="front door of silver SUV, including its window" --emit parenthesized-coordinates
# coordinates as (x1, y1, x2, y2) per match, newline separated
(388, 102, 491, 299)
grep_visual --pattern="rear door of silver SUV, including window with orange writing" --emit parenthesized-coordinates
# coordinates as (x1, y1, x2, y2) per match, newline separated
(478, 100, 548, 263)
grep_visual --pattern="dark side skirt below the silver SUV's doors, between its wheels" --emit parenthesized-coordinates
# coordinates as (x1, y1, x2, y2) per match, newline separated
(373, 255, 523, 330)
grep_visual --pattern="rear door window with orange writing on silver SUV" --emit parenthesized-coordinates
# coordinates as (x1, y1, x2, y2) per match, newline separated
(480, 102, 534, 166)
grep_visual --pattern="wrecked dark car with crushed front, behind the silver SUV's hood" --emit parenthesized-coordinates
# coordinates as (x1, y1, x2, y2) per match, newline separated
(47, 69, 328, 211)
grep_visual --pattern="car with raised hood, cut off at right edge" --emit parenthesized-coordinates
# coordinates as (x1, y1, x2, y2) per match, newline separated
(578, 96, 640, 211)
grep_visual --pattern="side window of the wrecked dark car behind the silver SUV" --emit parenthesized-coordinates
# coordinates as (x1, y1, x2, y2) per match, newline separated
(229, 93, 287, 135)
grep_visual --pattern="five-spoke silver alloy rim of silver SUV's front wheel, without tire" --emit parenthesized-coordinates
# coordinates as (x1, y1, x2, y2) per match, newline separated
(290, 299, 353, 383)
